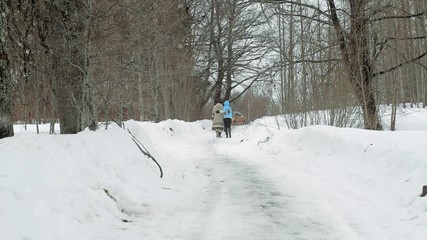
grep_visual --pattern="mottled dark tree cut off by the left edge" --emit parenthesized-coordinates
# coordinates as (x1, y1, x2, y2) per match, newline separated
(0, 1, 40, 135)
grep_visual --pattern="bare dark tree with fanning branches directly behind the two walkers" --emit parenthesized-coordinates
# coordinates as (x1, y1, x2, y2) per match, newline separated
(195, 0, 271, 105)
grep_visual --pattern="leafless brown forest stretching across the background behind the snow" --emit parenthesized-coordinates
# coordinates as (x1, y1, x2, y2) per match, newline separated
(0, 0, 427, 138)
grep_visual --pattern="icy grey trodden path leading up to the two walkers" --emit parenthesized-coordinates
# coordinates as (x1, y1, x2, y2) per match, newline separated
(177, 136, 338, 240)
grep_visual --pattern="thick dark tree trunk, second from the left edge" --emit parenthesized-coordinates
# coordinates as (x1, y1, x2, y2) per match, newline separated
(46, 1, 86, 134)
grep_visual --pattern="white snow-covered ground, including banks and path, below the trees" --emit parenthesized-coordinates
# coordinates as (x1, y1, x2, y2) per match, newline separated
(0, 109, 427, 240)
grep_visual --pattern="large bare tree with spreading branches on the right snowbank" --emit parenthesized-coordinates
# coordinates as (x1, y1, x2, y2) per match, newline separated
(254, 0, 426, 129)
